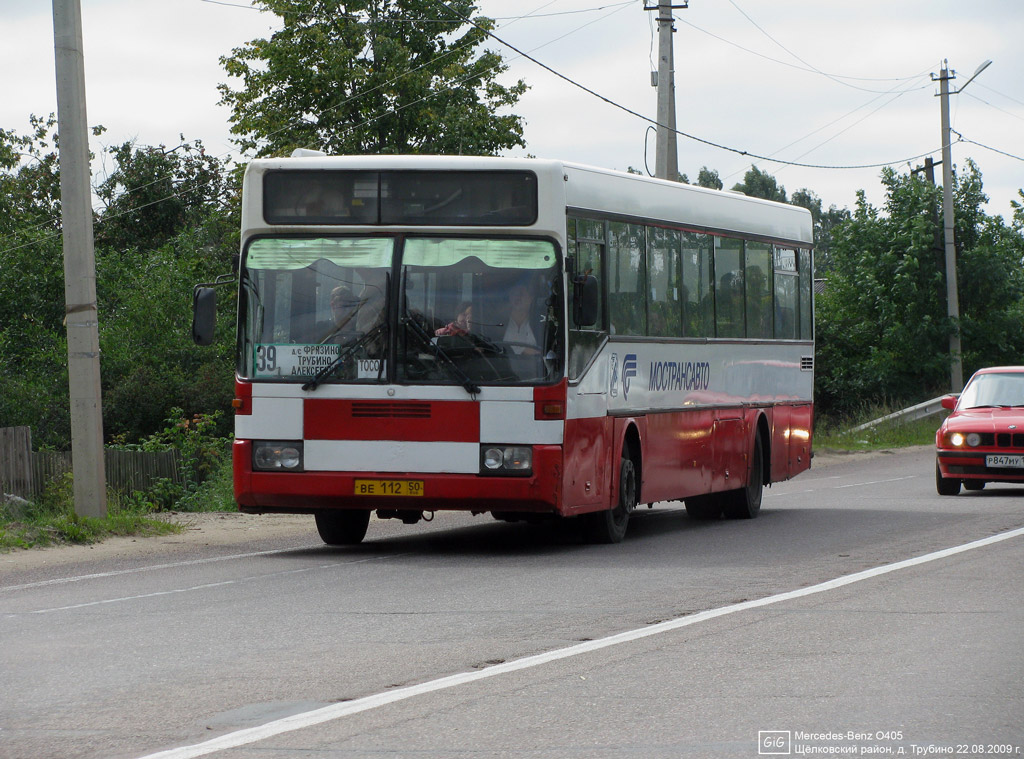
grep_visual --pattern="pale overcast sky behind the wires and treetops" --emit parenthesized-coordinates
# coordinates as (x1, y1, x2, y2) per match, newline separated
(0, 0, 1024, 219)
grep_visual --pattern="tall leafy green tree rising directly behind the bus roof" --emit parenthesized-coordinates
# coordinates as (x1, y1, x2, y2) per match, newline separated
(218, 0, 526, 157)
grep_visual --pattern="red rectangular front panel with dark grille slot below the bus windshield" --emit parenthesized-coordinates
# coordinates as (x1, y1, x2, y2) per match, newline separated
(302, 398, 480, 442)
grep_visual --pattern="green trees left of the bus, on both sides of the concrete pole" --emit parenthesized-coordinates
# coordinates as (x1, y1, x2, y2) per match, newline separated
(0, 117, 238, 448)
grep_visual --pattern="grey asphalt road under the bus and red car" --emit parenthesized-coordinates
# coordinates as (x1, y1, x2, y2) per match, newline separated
(0, 450, 1024, 759)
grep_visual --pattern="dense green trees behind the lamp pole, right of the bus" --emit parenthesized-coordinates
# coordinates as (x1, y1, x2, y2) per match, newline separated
(815, 162, 1024, 414)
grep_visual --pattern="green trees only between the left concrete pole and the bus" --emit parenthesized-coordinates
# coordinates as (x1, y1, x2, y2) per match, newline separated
(96, 138, 239, 441)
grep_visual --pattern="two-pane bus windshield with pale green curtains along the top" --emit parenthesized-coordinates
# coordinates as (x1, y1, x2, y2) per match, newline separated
(239, 237, 564, 389)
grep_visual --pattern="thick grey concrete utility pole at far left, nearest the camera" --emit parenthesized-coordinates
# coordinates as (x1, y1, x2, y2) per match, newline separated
(53, 0, 106, 517)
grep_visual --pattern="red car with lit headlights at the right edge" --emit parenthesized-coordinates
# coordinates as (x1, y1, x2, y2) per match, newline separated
(935, 367, 1024, 496)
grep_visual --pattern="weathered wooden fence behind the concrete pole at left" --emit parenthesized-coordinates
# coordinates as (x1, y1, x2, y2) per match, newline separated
(0, 427, 183, 499)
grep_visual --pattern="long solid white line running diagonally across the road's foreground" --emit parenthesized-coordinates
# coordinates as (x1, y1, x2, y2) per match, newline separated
(134, 528, 1024, 759)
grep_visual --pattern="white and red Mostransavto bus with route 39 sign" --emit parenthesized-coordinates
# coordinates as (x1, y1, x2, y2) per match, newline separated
(195, 156, 814, 544)
